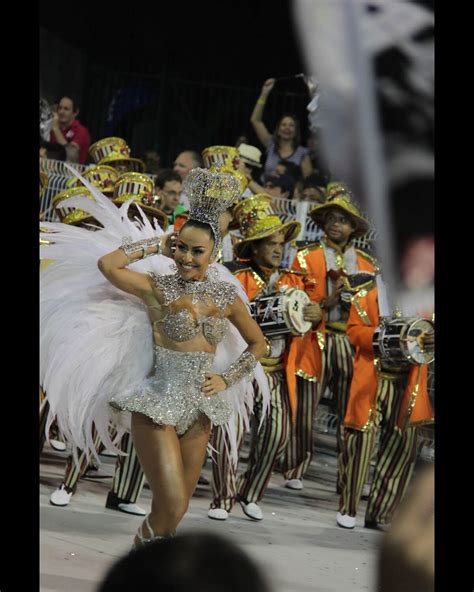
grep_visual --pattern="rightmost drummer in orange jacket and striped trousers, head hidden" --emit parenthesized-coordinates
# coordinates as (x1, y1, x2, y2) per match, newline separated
(336, 285, 434, 529)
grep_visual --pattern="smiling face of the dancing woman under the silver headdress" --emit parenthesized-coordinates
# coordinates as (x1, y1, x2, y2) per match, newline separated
(174, 226, 214, 281)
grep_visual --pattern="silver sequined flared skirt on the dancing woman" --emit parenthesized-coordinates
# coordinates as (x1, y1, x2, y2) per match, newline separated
(109, 345, 232, 436)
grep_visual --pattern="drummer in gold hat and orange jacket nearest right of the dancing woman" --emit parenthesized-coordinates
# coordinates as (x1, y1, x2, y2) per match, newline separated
(208, 194, 321, 520)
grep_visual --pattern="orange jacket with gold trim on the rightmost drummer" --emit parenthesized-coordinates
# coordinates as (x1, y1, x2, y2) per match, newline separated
(344, 288, 433, 431)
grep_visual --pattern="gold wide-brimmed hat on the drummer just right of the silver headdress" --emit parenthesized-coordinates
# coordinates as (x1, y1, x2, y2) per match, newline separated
(234, 193, 301, 259)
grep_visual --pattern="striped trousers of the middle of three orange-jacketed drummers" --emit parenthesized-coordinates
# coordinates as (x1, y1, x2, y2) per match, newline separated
(282, 330, 354, 479)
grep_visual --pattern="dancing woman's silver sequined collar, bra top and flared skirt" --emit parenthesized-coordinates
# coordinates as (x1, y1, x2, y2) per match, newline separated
(110, 273, 255, 435)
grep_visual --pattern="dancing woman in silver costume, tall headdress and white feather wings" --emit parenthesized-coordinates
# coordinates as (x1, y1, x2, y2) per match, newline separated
(41, 169, 268, 545)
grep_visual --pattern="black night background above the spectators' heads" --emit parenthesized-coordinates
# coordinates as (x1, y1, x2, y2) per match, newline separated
(39, 0, 308, 165)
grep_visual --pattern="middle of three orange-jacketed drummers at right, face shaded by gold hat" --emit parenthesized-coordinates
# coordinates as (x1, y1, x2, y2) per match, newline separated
(282, 183, 376, 490)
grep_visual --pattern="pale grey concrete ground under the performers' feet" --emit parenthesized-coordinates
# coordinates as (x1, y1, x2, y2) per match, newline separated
(40, 434, 383, 592)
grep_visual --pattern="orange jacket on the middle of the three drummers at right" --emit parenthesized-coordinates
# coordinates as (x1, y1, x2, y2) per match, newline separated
(286, 243, 376, 416)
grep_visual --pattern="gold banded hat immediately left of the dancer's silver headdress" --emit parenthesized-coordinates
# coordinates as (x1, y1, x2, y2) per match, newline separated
(112, 173, 168, 230)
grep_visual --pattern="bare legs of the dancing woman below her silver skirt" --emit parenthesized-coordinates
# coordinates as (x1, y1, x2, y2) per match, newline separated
(132, 413, 210, 538)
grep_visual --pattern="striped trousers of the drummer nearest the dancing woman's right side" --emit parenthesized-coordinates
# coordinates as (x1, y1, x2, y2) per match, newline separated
(211, 370, 289, 512)
